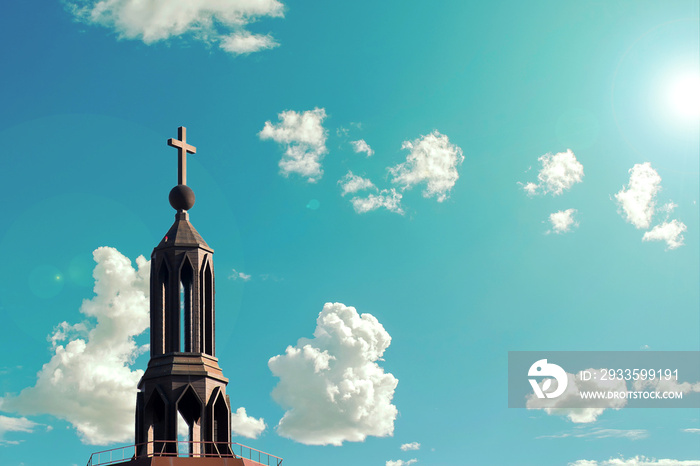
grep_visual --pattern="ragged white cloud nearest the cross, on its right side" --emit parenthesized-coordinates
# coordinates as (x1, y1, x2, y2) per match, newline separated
(258, 108, 328, 183)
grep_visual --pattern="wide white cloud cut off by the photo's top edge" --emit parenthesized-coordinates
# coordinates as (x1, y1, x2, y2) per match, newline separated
(66, 0, 284, 54)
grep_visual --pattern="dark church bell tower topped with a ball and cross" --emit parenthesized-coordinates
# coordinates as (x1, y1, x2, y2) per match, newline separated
(135, 127, 234, 457)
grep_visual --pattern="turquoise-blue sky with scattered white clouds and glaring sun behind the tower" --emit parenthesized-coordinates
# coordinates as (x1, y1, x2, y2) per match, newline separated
(0, 0, 700, 466)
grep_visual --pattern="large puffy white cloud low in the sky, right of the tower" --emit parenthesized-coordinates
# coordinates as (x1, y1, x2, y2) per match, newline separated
(268, 303, 398, 445)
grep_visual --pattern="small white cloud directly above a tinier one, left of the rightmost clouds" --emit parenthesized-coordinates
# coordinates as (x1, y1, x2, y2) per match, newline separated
(523, 149, 583, 196)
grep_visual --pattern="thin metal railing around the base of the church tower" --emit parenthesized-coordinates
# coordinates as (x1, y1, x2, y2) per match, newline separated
(87, 440, 282, 466)
